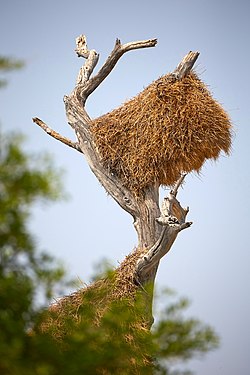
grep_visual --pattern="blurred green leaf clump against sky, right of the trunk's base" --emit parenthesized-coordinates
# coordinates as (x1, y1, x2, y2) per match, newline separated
(153, 290, 219, 374)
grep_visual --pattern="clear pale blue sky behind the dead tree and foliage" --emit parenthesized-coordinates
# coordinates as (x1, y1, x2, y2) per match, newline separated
(0, 0, 250, 375)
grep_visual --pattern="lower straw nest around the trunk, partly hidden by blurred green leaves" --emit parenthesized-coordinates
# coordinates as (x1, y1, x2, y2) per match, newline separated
(40, 249, 149, 341)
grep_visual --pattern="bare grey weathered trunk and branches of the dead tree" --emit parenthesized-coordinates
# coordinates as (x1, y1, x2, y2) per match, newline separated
(33, 35, 199, 292)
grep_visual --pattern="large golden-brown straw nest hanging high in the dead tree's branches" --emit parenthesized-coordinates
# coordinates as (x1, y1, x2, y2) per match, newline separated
(91, 71, 231, 194)
